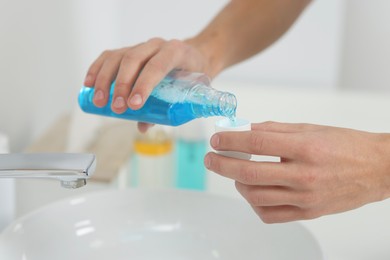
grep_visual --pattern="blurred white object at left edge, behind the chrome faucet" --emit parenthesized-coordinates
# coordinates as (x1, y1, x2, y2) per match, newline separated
(0, 133, 15, 232)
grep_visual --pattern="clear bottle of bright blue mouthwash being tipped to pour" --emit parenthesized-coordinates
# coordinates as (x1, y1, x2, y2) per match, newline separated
(79, 70, 237, 126)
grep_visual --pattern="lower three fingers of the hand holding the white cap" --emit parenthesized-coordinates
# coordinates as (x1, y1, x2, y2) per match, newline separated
(205, 153, 321, 223)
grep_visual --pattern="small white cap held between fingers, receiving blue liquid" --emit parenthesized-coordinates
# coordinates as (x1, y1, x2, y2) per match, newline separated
(215, 118, 252, 160)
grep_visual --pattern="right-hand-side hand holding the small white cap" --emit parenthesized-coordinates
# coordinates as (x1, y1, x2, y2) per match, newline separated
(205, 122, 390, 223)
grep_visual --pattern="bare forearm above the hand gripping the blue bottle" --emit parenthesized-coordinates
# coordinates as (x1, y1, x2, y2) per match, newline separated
(187, 0, 310, 77)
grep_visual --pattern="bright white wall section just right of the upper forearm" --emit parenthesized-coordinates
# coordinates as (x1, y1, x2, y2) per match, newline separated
(223, 0, 344, 89)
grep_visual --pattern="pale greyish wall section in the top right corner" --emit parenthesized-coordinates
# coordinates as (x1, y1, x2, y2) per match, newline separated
(340, 0, 390, 92)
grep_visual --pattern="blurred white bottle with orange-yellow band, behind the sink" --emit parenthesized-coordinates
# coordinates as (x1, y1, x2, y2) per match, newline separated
(129, 125, 174, 188)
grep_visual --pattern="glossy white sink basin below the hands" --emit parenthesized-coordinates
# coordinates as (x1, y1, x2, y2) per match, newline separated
(0, 189, 323, 260)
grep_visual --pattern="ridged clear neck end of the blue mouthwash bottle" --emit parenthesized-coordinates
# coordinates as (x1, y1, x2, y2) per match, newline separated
(188, 84, 237, 120)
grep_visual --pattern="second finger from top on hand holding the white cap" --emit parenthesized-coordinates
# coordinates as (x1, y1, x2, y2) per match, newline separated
(204, 152, 296, 186)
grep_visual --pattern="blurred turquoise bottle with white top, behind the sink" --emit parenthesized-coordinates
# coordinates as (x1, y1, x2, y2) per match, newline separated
(175, 121, 208, 190)
